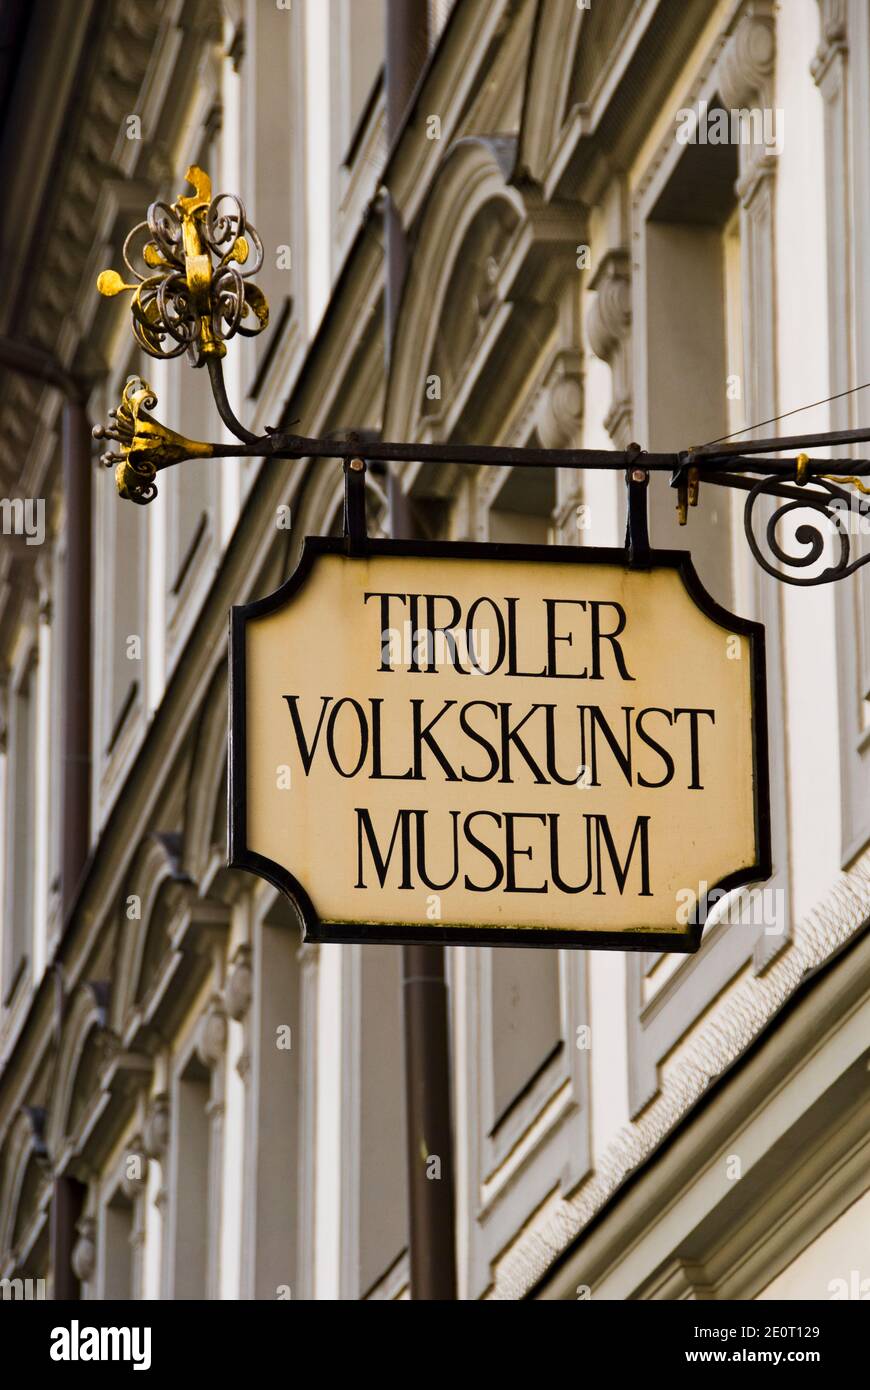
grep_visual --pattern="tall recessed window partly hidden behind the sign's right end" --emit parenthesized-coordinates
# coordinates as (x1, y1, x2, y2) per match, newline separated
(625, 65, 791, 1118)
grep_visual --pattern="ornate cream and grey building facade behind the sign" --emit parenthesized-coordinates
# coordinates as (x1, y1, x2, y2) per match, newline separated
(0, 0, 870, 1300)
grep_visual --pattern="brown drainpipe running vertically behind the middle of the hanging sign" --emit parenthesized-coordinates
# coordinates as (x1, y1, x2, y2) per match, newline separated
(384, 0, 456, 1300)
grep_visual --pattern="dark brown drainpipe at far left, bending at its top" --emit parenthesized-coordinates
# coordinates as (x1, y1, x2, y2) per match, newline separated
(0, 338, 92, 1300)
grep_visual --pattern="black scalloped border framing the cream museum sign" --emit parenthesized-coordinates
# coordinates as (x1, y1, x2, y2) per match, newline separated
(227, 535, 773, 954)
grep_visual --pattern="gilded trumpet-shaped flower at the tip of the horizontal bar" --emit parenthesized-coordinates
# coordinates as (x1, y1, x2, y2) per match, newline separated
(93, 377, 215, 506)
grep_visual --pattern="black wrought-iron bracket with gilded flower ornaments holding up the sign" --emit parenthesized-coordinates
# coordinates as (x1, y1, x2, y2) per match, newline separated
(86, 167, 870, 585)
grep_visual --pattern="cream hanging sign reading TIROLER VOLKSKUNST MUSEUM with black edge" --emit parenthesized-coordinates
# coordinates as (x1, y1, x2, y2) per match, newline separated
(229, 538, 770, 951)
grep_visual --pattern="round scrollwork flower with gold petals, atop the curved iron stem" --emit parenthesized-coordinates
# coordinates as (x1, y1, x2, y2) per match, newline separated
(97, 164, 268, 367)
